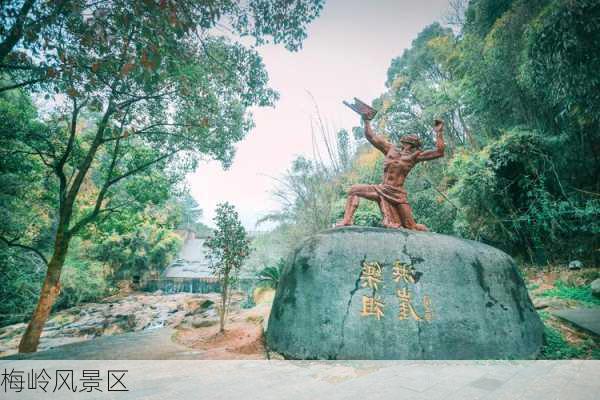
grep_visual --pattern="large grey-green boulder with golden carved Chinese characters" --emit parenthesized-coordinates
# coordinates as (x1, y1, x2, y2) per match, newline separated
(266, 227, 543, 359)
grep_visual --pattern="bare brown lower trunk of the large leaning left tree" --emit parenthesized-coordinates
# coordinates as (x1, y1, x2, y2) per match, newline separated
(19, 228, 70, 353)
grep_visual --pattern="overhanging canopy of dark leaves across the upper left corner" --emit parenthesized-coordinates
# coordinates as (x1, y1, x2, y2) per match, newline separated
(0, 0, 323, 93)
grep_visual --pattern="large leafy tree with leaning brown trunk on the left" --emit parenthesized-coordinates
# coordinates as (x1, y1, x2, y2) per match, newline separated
(0, 0, 322, 352)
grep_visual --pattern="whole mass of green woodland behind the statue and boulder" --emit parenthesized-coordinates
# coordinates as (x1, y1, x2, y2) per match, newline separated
(262, 0, 600, 270)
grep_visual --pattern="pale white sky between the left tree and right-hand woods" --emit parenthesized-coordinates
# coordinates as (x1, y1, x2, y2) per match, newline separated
(188, 0, 448, 230)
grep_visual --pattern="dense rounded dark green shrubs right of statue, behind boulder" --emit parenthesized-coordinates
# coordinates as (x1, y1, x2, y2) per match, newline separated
(449, 130, 600, 262)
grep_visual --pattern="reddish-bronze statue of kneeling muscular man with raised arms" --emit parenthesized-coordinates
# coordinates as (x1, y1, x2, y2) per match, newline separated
(337, 98, 445, 231)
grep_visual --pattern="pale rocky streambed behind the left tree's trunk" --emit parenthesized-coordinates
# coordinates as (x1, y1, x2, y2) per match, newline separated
(0, 291, 232, 357)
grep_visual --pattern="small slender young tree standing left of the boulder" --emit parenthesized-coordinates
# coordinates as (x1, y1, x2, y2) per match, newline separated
(204, 203, 251, 333)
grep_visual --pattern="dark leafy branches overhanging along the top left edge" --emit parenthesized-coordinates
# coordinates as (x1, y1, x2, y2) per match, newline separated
(0, 0, 323, 92)
